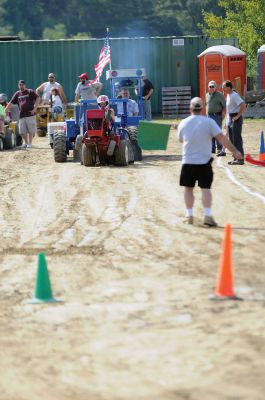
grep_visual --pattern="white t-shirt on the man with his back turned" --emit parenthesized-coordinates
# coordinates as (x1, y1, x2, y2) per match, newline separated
(177, 115, 222, 164)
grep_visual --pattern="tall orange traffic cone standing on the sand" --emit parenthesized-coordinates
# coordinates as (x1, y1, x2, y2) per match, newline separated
(212, 224, 241, 300)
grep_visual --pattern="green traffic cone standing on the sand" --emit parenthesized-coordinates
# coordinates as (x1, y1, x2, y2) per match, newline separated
(27, 253, 59, 304)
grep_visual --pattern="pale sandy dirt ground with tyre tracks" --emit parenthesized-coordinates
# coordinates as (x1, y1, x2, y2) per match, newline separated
(0, 120, 265, 400)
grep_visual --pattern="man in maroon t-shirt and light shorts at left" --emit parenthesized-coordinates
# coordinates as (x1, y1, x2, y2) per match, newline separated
(6, 79, 40, 148)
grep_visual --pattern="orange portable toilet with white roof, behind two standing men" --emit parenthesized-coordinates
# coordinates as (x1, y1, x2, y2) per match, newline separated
(198, 45, 246, 107)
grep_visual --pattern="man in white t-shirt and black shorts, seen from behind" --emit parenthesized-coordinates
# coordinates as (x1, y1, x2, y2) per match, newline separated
(177, 97, 243, 227)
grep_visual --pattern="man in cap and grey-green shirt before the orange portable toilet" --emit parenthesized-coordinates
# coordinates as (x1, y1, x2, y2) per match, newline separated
(206, 81, 226, 156)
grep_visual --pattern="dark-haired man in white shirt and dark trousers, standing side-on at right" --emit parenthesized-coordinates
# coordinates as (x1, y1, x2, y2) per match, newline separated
(223, 80, 246, 165)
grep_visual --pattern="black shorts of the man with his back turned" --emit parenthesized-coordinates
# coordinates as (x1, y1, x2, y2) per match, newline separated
(179, 158, 213, 189)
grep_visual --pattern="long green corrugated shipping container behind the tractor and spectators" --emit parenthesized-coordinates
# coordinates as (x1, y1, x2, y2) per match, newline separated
(0, 36, 237, 113)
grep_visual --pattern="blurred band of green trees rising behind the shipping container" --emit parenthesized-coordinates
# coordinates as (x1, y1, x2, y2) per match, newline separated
(0, 0, 265, 76)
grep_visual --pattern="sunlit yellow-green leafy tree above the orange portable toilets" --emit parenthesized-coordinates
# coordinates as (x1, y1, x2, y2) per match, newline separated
(203, 0, 265, 76)
